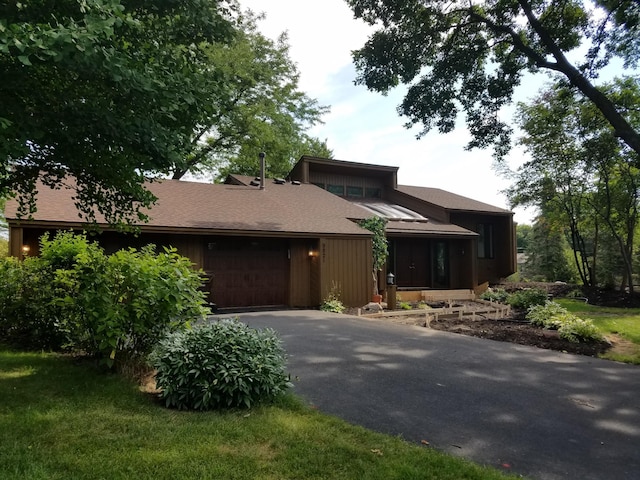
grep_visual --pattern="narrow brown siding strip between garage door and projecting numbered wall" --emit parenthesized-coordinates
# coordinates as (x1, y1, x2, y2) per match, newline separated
(289, 239, 318, 307)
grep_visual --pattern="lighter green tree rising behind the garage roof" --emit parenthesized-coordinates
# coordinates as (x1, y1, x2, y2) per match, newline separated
(173, 12, 332, 183)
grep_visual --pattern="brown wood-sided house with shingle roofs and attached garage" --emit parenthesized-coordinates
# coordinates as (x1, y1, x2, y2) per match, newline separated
(6, 156, 516, 308)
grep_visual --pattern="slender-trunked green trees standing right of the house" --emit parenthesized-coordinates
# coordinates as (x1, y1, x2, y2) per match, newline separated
(506, 78, 640, 290)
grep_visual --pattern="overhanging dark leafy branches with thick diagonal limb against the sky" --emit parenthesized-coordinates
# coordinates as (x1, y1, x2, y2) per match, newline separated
(347, 0, 640, 159)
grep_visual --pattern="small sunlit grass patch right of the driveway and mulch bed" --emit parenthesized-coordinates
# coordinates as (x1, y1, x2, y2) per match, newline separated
(554, 298, 640, 365)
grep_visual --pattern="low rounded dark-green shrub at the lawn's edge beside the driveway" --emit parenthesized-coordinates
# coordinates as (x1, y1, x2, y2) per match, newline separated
(150, 319, 292, 410)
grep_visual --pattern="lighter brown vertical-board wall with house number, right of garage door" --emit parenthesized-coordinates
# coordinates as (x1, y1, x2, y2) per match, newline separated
(319, 238, 373, 307)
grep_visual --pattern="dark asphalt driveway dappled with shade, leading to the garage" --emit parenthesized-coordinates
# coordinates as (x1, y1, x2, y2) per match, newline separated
(214, 310, 640, 480)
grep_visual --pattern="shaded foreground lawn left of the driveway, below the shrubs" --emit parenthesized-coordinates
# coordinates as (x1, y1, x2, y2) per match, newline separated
(0, 349, 507, 480)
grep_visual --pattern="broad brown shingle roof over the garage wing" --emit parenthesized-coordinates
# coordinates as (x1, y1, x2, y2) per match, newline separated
(5, 180, 370, 235)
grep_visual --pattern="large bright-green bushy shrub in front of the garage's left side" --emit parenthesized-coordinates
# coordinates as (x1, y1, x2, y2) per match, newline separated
(0, 232, 206, 366)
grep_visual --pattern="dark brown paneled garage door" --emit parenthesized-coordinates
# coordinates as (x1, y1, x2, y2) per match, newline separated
(205, 238, 289, 308)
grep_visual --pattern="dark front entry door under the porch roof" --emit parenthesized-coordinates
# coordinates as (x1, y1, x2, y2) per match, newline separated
(394, 238, 429, 288)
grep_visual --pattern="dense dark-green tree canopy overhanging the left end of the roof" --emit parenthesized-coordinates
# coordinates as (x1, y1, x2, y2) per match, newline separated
(0, 0, 237, 223)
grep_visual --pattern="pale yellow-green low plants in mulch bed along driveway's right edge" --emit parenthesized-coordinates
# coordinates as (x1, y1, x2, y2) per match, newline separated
(527, 302, 603, 343)
